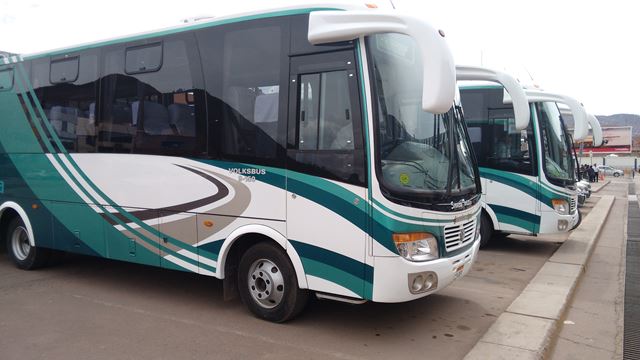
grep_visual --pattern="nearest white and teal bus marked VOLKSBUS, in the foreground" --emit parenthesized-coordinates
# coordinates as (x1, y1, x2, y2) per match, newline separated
(0, 6, 481, 322)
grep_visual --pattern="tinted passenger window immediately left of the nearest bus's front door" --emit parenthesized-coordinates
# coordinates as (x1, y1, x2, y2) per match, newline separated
(198, 18, 288, 166)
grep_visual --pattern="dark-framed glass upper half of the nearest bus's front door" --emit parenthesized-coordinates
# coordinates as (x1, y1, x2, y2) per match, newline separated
(288, 51, 366, 185)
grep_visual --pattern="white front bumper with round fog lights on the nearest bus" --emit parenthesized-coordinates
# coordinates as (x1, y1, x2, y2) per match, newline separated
(372, 239, 480, 303)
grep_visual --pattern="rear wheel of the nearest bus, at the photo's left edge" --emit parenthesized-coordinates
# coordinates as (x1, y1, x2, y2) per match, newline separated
(6, 217, 51, 270)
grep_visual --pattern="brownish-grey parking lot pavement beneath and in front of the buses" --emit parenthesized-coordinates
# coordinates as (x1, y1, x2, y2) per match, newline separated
(0, 203, 589, 359)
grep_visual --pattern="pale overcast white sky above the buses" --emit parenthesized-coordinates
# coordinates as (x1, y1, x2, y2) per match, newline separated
(0, 0, 640, 115)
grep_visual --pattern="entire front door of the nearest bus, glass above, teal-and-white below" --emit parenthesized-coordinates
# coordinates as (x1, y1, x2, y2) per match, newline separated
(287, 51, 368, 296)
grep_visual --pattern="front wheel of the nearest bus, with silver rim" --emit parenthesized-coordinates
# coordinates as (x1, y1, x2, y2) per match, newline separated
(238, 243, 308, 323)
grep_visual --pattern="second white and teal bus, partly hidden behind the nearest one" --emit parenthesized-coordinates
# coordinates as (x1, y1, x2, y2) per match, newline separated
(460, 78, 587, 246)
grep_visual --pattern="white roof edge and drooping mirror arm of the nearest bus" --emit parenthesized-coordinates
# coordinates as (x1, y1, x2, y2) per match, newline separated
(2, 3, 456, 113)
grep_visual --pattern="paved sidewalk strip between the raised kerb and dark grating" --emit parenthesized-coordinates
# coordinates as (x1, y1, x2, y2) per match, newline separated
(549, 182, 628, 360)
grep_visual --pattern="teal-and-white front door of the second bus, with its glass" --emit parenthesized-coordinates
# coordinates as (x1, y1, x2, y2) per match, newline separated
(483, 108, 539, 233)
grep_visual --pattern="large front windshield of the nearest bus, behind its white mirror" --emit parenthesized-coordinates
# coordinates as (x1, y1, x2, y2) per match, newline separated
(367, 34, 478, 207)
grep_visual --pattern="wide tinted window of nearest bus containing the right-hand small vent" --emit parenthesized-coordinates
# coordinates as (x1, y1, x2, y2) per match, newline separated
(98, 34, 206, 156)
